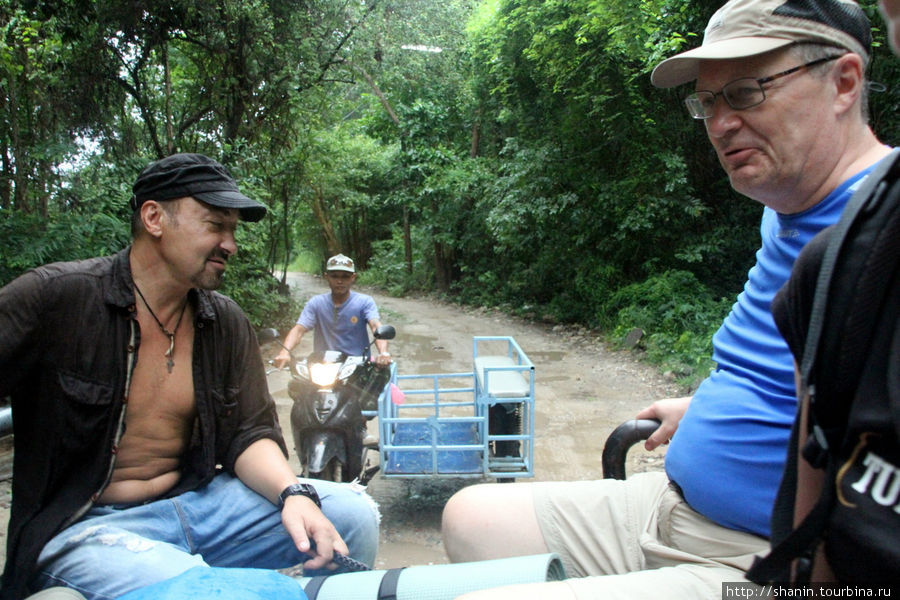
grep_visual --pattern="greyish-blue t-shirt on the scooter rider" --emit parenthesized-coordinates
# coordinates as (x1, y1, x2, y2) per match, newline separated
(297, 290, 381, 356)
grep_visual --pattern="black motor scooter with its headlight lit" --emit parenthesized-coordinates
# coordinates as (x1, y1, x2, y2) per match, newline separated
(280, 325, 396, 485)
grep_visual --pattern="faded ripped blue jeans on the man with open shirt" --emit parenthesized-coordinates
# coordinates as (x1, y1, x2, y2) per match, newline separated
(38, 474, 379, 600)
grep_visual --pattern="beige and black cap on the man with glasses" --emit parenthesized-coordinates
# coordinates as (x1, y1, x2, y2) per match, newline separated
(650, 0, 872, 88)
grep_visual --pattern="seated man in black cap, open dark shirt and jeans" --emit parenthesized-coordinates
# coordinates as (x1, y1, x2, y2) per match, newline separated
(0, 154, 378, 598)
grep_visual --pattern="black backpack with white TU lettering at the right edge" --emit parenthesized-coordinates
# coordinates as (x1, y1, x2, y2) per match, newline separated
(747, 150, 900, 584)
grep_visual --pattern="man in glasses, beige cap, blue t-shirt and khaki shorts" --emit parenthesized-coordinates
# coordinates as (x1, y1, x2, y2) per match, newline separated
(443, 0, 890, 600)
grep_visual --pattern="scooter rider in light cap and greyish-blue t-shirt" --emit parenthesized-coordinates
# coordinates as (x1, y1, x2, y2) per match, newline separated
(275, 254, 391, 369)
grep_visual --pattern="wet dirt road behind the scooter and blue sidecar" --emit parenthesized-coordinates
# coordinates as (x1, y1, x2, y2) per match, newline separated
(0, 274, 679, 568)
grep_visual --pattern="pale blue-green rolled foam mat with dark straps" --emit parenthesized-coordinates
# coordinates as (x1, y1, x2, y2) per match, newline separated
(297, 554, 566, 600)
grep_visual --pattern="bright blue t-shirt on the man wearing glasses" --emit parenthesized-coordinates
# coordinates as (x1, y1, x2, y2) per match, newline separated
(666, 168, 871, 537)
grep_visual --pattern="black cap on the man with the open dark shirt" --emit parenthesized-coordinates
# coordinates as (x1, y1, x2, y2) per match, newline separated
(131, 154, 266, 221)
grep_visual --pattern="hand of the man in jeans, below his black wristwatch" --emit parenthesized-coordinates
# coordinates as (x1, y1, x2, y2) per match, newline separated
(281, 496, 349, 569)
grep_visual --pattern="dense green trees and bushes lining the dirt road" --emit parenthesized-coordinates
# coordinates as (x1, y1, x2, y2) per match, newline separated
(0, 0, 900, 384)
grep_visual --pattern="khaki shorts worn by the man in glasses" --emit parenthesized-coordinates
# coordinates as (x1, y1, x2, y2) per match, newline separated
(531, 472, 769, 600)
